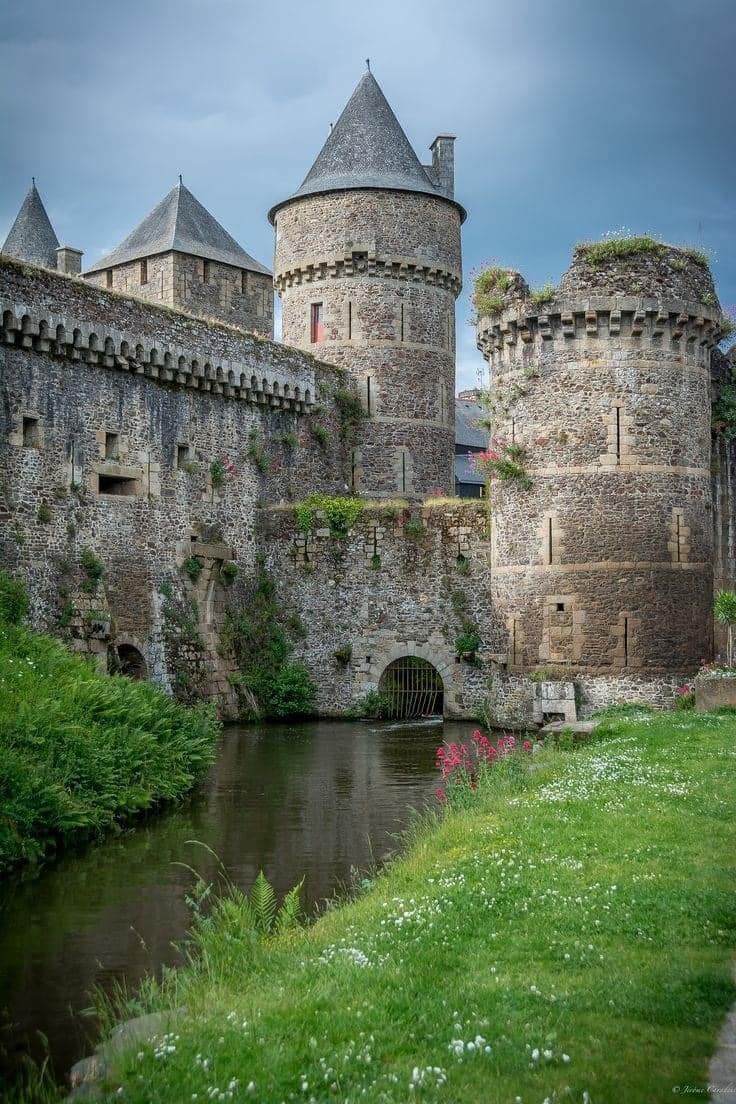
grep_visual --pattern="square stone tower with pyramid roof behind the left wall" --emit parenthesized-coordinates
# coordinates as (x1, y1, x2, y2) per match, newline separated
(84, 177, 274, 337)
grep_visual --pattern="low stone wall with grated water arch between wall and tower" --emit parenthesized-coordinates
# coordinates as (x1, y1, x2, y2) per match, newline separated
(257, 502, 505, 718)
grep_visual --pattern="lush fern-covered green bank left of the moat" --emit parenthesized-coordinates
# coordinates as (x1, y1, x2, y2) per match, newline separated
(0, 613, 218, 871)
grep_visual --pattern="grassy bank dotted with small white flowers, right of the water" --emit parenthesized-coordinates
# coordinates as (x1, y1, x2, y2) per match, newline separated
(64, 711, 736, 1104)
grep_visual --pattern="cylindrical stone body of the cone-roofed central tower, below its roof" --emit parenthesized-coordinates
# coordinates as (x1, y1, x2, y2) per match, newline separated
(275, 191, 461, 498)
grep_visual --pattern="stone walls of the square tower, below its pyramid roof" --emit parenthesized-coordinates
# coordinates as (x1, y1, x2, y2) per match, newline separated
(85, 253, 274, 338)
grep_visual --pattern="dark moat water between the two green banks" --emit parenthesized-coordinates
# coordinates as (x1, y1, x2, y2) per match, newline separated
(0, 722, 454, 1085)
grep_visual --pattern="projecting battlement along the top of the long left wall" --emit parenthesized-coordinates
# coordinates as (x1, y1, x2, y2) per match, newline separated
(0, 257, 320, 413)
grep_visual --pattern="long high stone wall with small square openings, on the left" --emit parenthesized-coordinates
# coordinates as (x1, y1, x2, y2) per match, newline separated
(0, 261, 344, 702)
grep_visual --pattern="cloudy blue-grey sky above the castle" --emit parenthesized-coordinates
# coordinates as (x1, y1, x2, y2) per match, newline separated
(0, 0, 736, 385)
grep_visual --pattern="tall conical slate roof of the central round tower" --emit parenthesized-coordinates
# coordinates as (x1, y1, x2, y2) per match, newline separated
(268, 68, 465, 222)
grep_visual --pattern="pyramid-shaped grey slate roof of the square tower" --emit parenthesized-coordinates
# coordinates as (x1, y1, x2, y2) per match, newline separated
(87, 178, 270, 275)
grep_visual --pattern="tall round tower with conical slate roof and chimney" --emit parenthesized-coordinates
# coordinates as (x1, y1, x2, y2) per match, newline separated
(269, 71, 465, 497)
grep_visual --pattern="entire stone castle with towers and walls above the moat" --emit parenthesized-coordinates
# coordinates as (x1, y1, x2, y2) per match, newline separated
(0, 71, 734, 721)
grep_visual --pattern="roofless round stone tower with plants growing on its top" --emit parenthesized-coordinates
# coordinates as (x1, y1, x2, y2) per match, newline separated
(478, 242, 722, 681)
